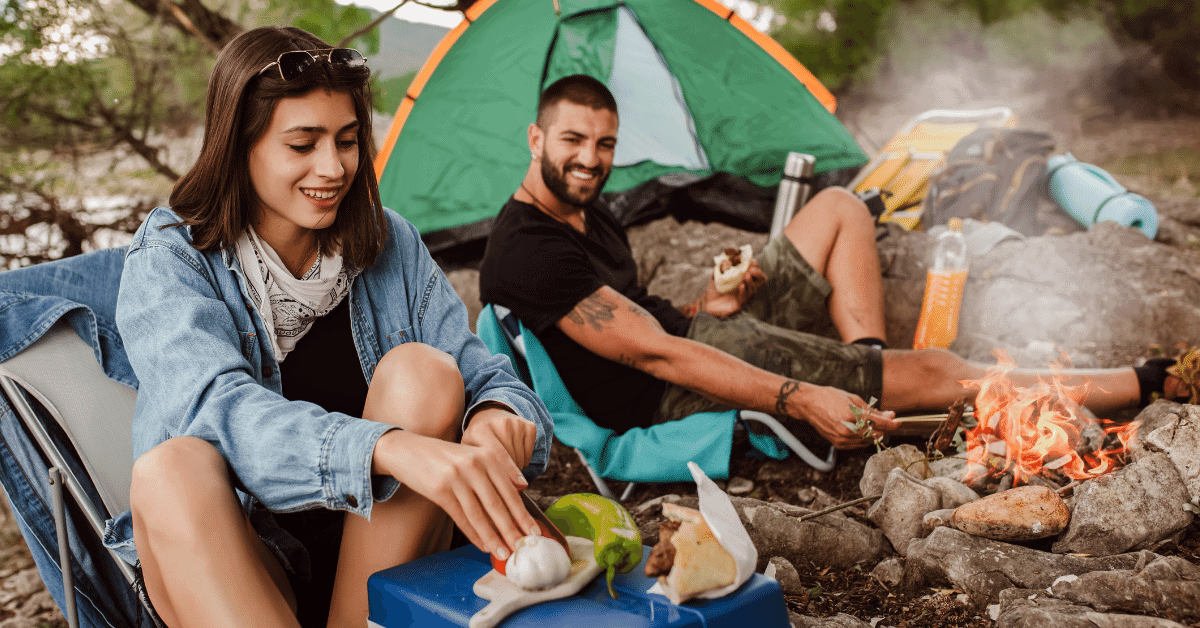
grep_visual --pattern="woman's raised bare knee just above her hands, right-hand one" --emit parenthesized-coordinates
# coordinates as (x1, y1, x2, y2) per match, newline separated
(364, 342, 466, 437)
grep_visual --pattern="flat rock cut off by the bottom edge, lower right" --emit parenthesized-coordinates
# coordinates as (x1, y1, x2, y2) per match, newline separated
(996, 588, 1183, 628)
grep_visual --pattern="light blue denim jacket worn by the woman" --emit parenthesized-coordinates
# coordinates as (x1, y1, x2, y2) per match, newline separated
(2, 208, 553, 562)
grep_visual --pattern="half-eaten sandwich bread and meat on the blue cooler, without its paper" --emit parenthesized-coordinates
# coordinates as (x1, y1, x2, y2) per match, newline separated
(646, 503, 738, 604)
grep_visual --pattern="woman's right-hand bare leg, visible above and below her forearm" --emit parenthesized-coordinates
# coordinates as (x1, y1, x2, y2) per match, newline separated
(329, 342, 466, 628)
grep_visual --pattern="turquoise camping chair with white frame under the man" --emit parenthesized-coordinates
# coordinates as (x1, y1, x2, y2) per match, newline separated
(475, 305, 836, 501)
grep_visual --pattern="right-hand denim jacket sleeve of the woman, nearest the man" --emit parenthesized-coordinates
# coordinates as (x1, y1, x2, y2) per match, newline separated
(376, 211, 554, 480)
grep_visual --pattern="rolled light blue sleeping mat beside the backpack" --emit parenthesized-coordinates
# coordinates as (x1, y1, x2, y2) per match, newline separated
(1046, 152, 1158, 239)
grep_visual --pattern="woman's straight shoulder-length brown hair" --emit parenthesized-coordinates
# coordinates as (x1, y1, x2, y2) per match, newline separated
(170, 26, 386, 268)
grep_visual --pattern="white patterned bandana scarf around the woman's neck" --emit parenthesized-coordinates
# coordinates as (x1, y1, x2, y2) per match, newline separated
(235, 227, 356, 361)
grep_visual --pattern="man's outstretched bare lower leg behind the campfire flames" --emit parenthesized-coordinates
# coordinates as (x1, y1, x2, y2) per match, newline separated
(880, 349, 1141, 413)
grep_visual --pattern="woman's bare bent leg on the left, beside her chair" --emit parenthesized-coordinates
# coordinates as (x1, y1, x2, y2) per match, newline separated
(130, 437, 299, 628)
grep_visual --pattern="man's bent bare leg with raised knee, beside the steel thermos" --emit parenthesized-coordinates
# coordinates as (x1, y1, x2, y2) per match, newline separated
(784, 187, 887, 342)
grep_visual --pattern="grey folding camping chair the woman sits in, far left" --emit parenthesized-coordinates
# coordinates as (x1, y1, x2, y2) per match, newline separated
(0, 321, 156, 628)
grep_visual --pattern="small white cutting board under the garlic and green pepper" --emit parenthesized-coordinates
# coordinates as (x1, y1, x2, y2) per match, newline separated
(468, 537, 604, 628)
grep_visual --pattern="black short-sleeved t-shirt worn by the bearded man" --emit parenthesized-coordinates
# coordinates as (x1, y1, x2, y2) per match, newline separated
(479, 199, 689, 432)
